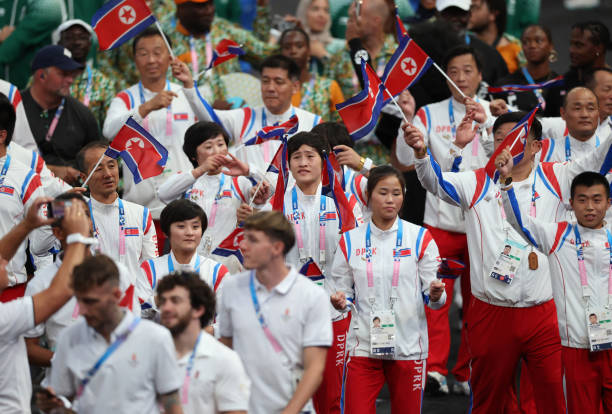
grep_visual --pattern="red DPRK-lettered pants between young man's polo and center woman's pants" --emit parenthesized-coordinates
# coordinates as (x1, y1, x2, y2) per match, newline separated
(312, 313, 351, 414)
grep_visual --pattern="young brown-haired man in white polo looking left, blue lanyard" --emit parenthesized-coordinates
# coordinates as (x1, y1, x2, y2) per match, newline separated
(218, 211, 332, 414)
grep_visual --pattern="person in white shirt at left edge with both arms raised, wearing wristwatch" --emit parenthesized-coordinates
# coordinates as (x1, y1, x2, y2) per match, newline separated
(0, 198, 89, 414)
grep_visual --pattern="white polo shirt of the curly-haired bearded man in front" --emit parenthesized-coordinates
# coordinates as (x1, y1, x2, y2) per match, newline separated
(178, 331, 251, 414)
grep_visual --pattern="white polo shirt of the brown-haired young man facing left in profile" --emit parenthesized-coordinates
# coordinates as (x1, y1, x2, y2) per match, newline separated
(218, 267, 332, 414)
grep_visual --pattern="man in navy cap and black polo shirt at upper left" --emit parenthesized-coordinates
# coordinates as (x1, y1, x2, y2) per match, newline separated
(15, 45, 100, 184)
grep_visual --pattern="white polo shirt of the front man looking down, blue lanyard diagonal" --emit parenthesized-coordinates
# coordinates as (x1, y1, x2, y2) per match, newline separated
(49, 312, 183, 414)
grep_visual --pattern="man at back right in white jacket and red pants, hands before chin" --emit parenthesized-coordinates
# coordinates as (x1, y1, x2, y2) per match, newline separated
(396, 46, 493, 394)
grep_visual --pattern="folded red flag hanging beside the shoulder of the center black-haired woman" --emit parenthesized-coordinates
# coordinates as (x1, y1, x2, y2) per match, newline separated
(321, 153, 355, 233)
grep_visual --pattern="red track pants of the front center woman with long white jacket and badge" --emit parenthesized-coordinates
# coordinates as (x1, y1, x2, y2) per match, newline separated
(344, 357, 426, 414)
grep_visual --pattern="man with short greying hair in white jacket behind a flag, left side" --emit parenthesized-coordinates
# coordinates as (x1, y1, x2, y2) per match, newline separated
(76, 141, 157, 286)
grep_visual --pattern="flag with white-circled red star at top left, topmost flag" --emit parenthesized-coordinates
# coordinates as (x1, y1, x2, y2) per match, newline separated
(91, 0, 155, 50)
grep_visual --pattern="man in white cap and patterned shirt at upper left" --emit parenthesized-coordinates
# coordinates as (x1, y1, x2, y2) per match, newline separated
(51, 19, 115, 127)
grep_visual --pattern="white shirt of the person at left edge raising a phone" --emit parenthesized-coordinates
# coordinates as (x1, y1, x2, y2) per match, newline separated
(0, 297, 34, 414)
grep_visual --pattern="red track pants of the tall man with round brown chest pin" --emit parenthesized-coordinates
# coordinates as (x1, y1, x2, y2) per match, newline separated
(467, 298, 565, 414)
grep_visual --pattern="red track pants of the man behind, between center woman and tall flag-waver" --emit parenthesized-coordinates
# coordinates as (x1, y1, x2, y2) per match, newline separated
(425, 226, 472, 381)
